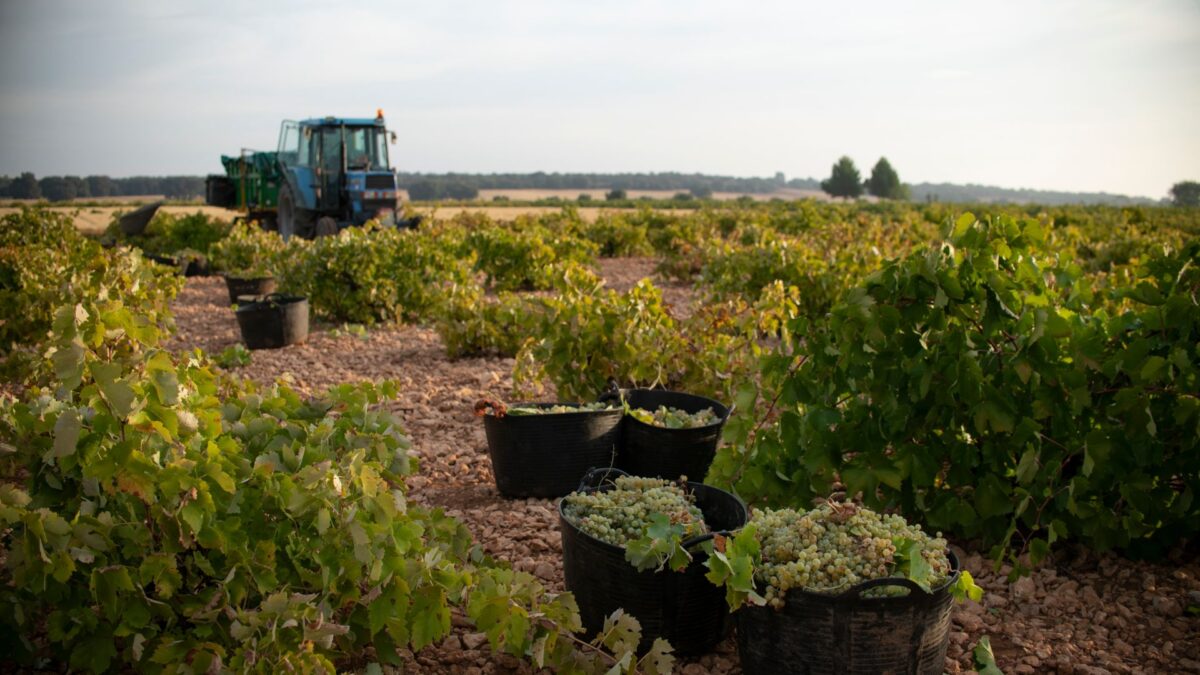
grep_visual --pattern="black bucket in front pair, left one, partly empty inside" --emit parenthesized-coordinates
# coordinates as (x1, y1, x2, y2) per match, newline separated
(558, 470, 748, 655)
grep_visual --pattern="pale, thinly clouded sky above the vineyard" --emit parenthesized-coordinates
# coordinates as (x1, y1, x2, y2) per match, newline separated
(0, 0, 1200, 198)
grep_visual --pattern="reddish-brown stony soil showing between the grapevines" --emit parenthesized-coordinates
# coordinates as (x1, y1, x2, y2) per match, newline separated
(170, 259, 1200, 675)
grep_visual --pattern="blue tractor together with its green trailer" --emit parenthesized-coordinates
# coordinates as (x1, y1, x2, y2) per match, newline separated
(206, 110, 418, 239)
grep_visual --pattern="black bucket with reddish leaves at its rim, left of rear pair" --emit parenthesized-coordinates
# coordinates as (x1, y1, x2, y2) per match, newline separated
(484, 404, 624, 497)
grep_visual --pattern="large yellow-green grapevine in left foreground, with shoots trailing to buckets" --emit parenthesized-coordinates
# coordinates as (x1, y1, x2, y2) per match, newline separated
(0, 212, 673, 673)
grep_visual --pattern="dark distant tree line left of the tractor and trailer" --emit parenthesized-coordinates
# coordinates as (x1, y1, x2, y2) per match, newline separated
(0, 172, 204, 202)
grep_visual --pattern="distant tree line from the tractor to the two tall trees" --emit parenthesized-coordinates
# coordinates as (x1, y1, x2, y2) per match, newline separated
(397, 172, 817, 199)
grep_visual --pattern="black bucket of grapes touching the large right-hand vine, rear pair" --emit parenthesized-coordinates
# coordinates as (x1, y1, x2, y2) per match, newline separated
(600, 389, 730, 482)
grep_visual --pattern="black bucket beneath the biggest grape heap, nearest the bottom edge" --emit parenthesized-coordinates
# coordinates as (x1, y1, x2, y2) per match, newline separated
(734, 552, 959, 675)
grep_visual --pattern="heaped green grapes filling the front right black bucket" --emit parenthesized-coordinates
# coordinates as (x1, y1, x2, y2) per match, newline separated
(755, 502, 952, 609)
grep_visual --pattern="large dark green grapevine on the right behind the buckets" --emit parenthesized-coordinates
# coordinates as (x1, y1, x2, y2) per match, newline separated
(710, 215, 1200, 562)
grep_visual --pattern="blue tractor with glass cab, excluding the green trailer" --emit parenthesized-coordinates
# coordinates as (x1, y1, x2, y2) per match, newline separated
(277, 110, 398, 237)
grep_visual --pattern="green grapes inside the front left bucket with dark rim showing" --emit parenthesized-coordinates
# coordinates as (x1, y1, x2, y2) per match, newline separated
(563, 476, 708, 569)
